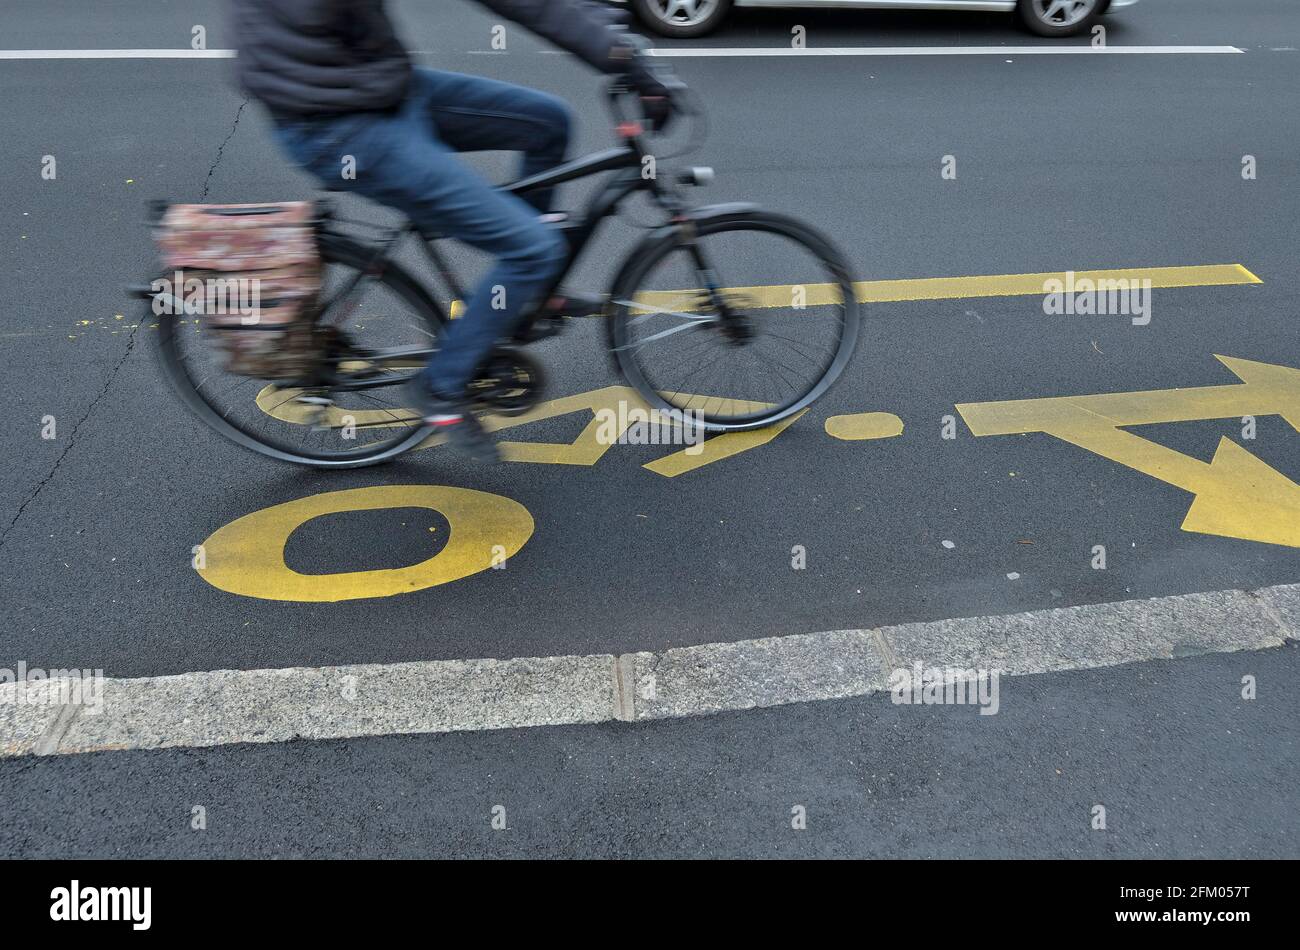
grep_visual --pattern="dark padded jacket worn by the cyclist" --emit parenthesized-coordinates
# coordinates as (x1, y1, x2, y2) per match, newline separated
(231, 0, 632, 116)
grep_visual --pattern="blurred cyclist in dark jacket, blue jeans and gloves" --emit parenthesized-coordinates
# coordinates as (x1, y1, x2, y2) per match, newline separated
(231, 0, 673, 461)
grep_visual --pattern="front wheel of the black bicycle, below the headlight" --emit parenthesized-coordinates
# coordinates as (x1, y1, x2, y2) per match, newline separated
(610, 211, 858, 431)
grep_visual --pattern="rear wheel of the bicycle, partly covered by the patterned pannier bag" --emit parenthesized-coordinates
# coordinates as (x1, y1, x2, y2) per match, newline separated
(159, 233, 442, 468)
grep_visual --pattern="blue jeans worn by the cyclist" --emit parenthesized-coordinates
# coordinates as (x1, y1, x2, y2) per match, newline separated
(276, 69, 569, 399)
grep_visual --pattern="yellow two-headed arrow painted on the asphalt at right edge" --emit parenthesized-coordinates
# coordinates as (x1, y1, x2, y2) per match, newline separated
(957, 356, 1300, 547)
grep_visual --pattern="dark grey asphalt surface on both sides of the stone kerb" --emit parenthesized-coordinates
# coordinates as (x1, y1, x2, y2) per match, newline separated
(0, 0, 1300, 856)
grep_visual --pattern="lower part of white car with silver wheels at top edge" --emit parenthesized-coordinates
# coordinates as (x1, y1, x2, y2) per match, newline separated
(628, 0, 1138, 38)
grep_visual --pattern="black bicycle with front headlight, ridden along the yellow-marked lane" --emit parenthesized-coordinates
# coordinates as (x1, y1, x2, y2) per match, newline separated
(139, 82, 858, 468)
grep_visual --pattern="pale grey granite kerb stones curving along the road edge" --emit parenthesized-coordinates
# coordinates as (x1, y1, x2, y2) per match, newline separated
(0, 585, 1300, 758)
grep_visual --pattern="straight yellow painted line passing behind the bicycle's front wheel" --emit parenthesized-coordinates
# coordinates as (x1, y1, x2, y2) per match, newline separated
(636, 264, 1262, 313)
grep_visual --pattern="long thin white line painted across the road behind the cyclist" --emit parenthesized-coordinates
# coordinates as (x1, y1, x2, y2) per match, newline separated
(0, 45, 1245, 60)
